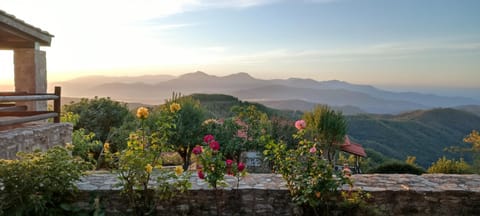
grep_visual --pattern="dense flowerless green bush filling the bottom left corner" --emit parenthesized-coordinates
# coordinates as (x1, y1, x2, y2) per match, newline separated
(0, 147, 91, 215)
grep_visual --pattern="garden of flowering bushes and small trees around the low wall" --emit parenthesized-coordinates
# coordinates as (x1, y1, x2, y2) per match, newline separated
(0, 94, 480, 215)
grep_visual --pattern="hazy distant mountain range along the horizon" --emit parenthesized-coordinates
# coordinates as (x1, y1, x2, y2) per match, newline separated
(51, 71, 480, 114)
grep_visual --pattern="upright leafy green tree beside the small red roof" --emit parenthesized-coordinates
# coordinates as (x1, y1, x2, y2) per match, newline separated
(303, 106, 347, 164)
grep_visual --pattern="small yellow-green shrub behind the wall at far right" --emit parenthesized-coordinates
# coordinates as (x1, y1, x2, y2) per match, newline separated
(427, 156, 472, 174)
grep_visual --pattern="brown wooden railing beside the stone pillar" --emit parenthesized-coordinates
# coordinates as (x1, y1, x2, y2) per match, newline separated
(0, 86, 61, 126)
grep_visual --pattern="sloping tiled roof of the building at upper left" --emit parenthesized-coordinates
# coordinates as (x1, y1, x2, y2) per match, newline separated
(0, 10, 53, 49)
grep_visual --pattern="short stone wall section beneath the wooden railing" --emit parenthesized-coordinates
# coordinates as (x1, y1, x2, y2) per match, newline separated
(0, 123, 73, 159)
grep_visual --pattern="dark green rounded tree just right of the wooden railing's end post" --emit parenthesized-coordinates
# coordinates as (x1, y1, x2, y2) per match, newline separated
(64, 97, 133, 142)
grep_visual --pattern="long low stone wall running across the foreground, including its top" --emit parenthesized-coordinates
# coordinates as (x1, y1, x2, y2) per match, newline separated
(76, 172, 480, 215)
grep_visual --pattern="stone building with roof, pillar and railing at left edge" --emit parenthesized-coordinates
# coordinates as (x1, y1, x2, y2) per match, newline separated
(0, 10, 72, 159)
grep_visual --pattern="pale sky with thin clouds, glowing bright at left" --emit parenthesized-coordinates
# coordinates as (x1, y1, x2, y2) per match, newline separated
(0, 0, 480, 89)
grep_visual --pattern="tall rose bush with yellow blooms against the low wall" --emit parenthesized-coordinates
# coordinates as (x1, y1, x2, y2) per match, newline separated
(109, 107, 190, 215)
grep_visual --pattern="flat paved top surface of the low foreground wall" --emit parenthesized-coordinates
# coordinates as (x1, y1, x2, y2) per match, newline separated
(77, 171, 480, 193)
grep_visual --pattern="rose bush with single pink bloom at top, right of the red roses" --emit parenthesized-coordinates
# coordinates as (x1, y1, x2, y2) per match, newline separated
(264, 121, 350, 213)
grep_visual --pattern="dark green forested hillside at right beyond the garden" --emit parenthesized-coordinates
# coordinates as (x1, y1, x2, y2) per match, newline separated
(347, 109, 480, 168)
